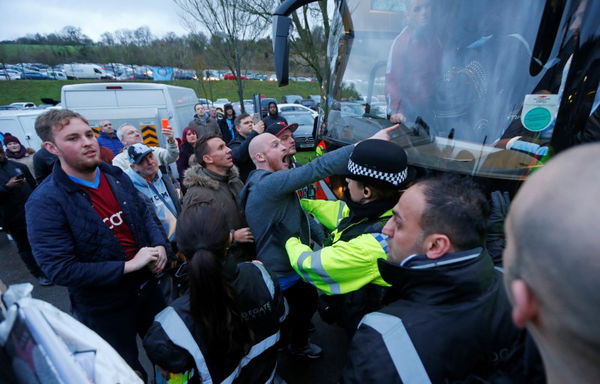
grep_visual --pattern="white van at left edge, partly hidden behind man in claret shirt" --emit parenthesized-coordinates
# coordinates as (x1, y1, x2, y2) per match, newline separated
(0, 109, 47, 151)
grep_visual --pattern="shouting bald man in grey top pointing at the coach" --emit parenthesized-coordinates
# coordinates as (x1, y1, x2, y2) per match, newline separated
(241, 126, 397, 359)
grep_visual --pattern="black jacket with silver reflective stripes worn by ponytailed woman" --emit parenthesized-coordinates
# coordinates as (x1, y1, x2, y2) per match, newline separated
(144, 262, 286, 383)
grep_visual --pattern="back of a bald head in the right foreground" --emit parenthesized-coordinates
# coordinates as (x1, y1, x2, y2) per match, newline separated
(504, 144, 600, 383)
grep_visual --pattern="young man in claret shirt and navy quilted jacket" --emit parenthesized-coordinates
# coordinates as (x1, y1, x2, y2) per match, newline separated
(25, 109, 167, 377)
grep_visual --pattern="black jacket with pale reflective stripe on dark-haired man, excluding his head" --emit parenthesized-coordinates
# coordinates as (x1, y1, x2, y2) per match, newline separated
(342, 248, 519, 383)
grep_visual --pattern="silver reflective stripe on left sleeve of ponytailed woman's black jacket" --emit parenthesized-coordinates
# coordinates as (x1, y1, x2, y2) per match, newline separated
(154, 307, 212, 384)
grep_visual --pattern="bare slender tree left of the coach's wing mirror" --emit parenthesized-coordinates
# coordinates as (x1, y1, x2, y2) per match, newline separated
(173, 0, 267, 110)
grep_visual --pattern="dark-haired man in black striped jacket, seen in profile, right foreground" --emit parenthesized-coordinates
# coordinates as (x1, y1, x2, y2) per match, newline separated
(342, 177, 520, 383)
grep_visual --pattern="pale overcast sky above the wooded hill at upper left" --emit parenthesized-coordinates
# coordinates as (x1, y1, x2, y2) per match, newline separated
(0, 0, 187, 41)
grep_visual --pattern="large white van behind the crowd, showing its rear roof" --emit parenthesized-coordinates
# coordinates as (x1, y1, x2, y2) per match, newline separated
(61, 83, 198, 142)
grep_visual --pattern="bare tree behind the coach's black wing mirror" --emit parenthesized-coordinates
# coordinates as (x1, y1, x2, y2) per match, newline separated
(240, 0, 330, 93)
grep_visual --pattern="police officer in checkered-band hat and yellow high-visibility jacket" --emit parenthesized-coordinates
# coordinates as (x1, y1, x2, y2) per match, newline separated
(285, 140, 414, 334)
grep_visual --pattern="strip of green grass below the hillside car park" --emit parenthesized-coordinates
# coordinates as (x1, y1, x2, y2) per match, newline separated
(0, 80, 319, 105)
